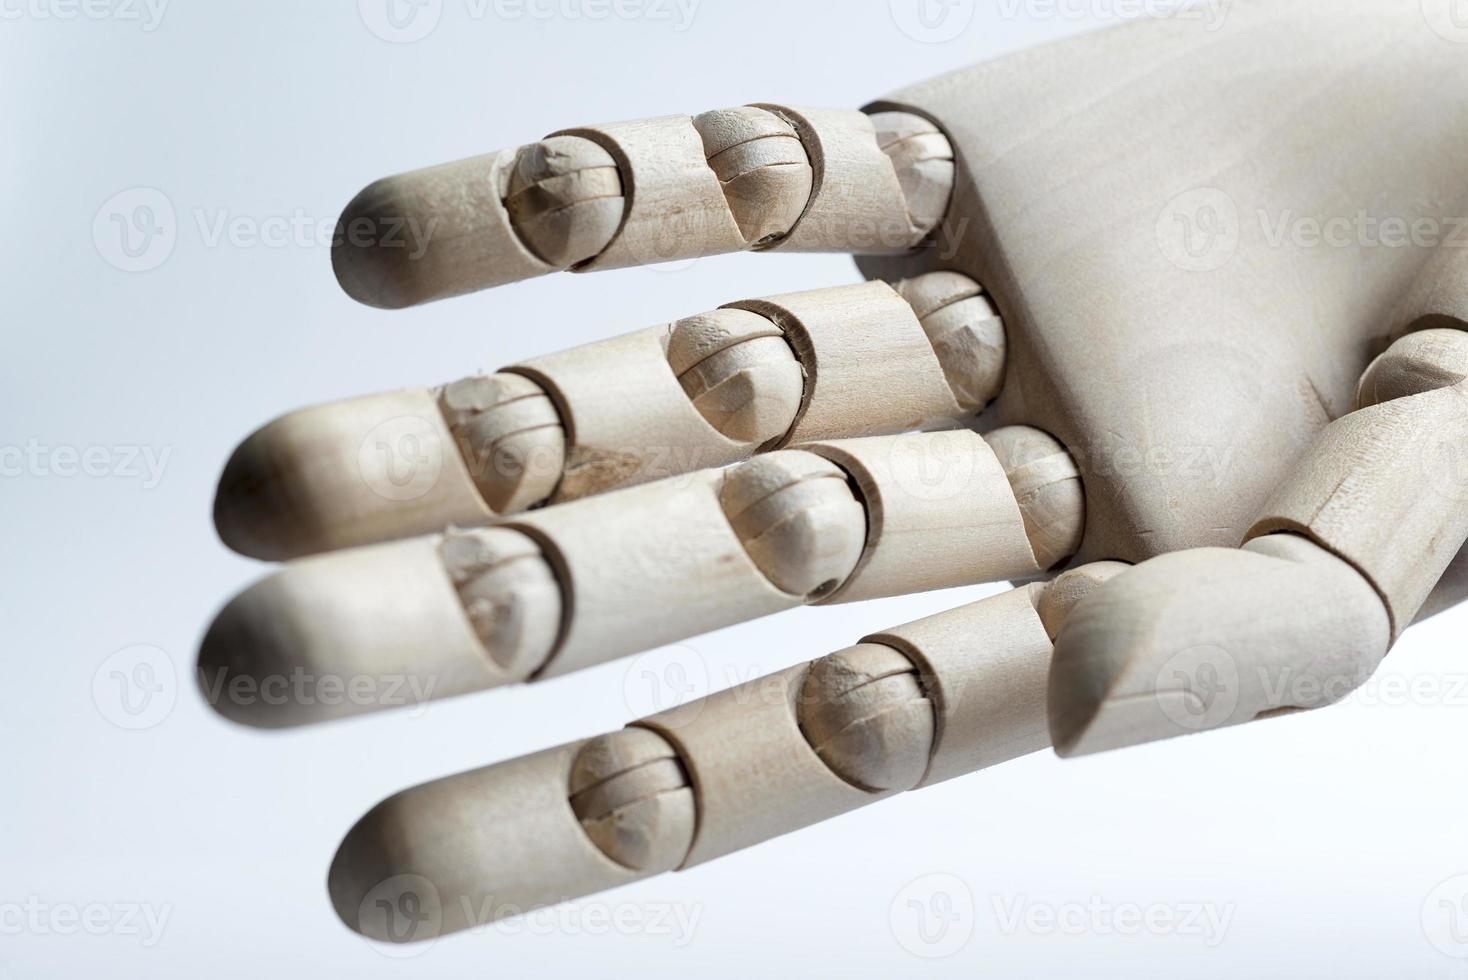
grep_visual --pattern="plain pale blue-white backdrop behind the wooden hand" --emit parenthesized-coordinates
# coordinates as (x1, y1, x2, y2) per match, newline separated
(0, 0, 1468, 980)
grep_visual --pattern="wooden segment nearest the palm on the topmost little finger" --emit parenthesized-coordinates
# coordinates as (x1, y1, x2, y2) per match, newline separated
(759, 104, 922, 255)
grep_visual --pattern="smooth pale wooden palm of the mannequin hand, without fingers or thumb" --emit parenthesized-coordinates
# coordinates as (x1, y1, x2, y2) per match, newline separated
(860, 0, 1468, 560)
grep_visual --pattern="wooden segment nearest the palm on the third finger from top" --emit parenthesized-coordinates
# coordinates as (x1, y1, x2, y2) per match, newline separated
(804, 430, 1042, 601)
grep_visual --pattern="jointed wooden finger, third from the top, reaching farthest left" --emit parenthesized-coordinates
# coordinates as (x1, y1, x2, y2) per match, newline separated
(200, 430, 1082, 726)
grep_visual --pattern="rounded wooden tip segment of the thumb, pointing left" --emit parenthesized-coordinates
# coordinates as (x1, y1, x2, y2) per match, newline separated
(1047, 534, 1392, 756)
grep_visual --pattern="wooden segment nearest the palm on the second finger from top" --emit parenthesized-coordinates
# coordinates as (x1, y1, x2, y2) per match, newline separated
(727, 282, 964, 445)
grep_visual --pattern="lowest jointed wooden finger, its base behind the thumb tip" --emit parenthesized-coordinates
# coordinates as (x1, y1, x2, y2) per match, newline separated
(329, 566, 1122, 942)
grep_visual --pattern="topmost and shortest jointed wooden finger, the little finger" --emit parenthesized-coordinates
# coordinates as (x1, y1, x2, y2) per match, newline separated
(332, 106, 953, 308)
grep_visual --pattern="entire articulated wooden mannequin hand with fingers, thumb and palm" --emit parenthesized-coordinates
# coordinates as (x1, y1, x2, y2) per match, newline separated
(200, 0, 1468, 939)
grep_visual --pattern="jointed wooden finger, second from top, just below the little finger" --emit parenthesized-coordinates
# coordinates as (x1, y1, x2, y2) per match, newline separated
(214, 273, 1004, 559)
